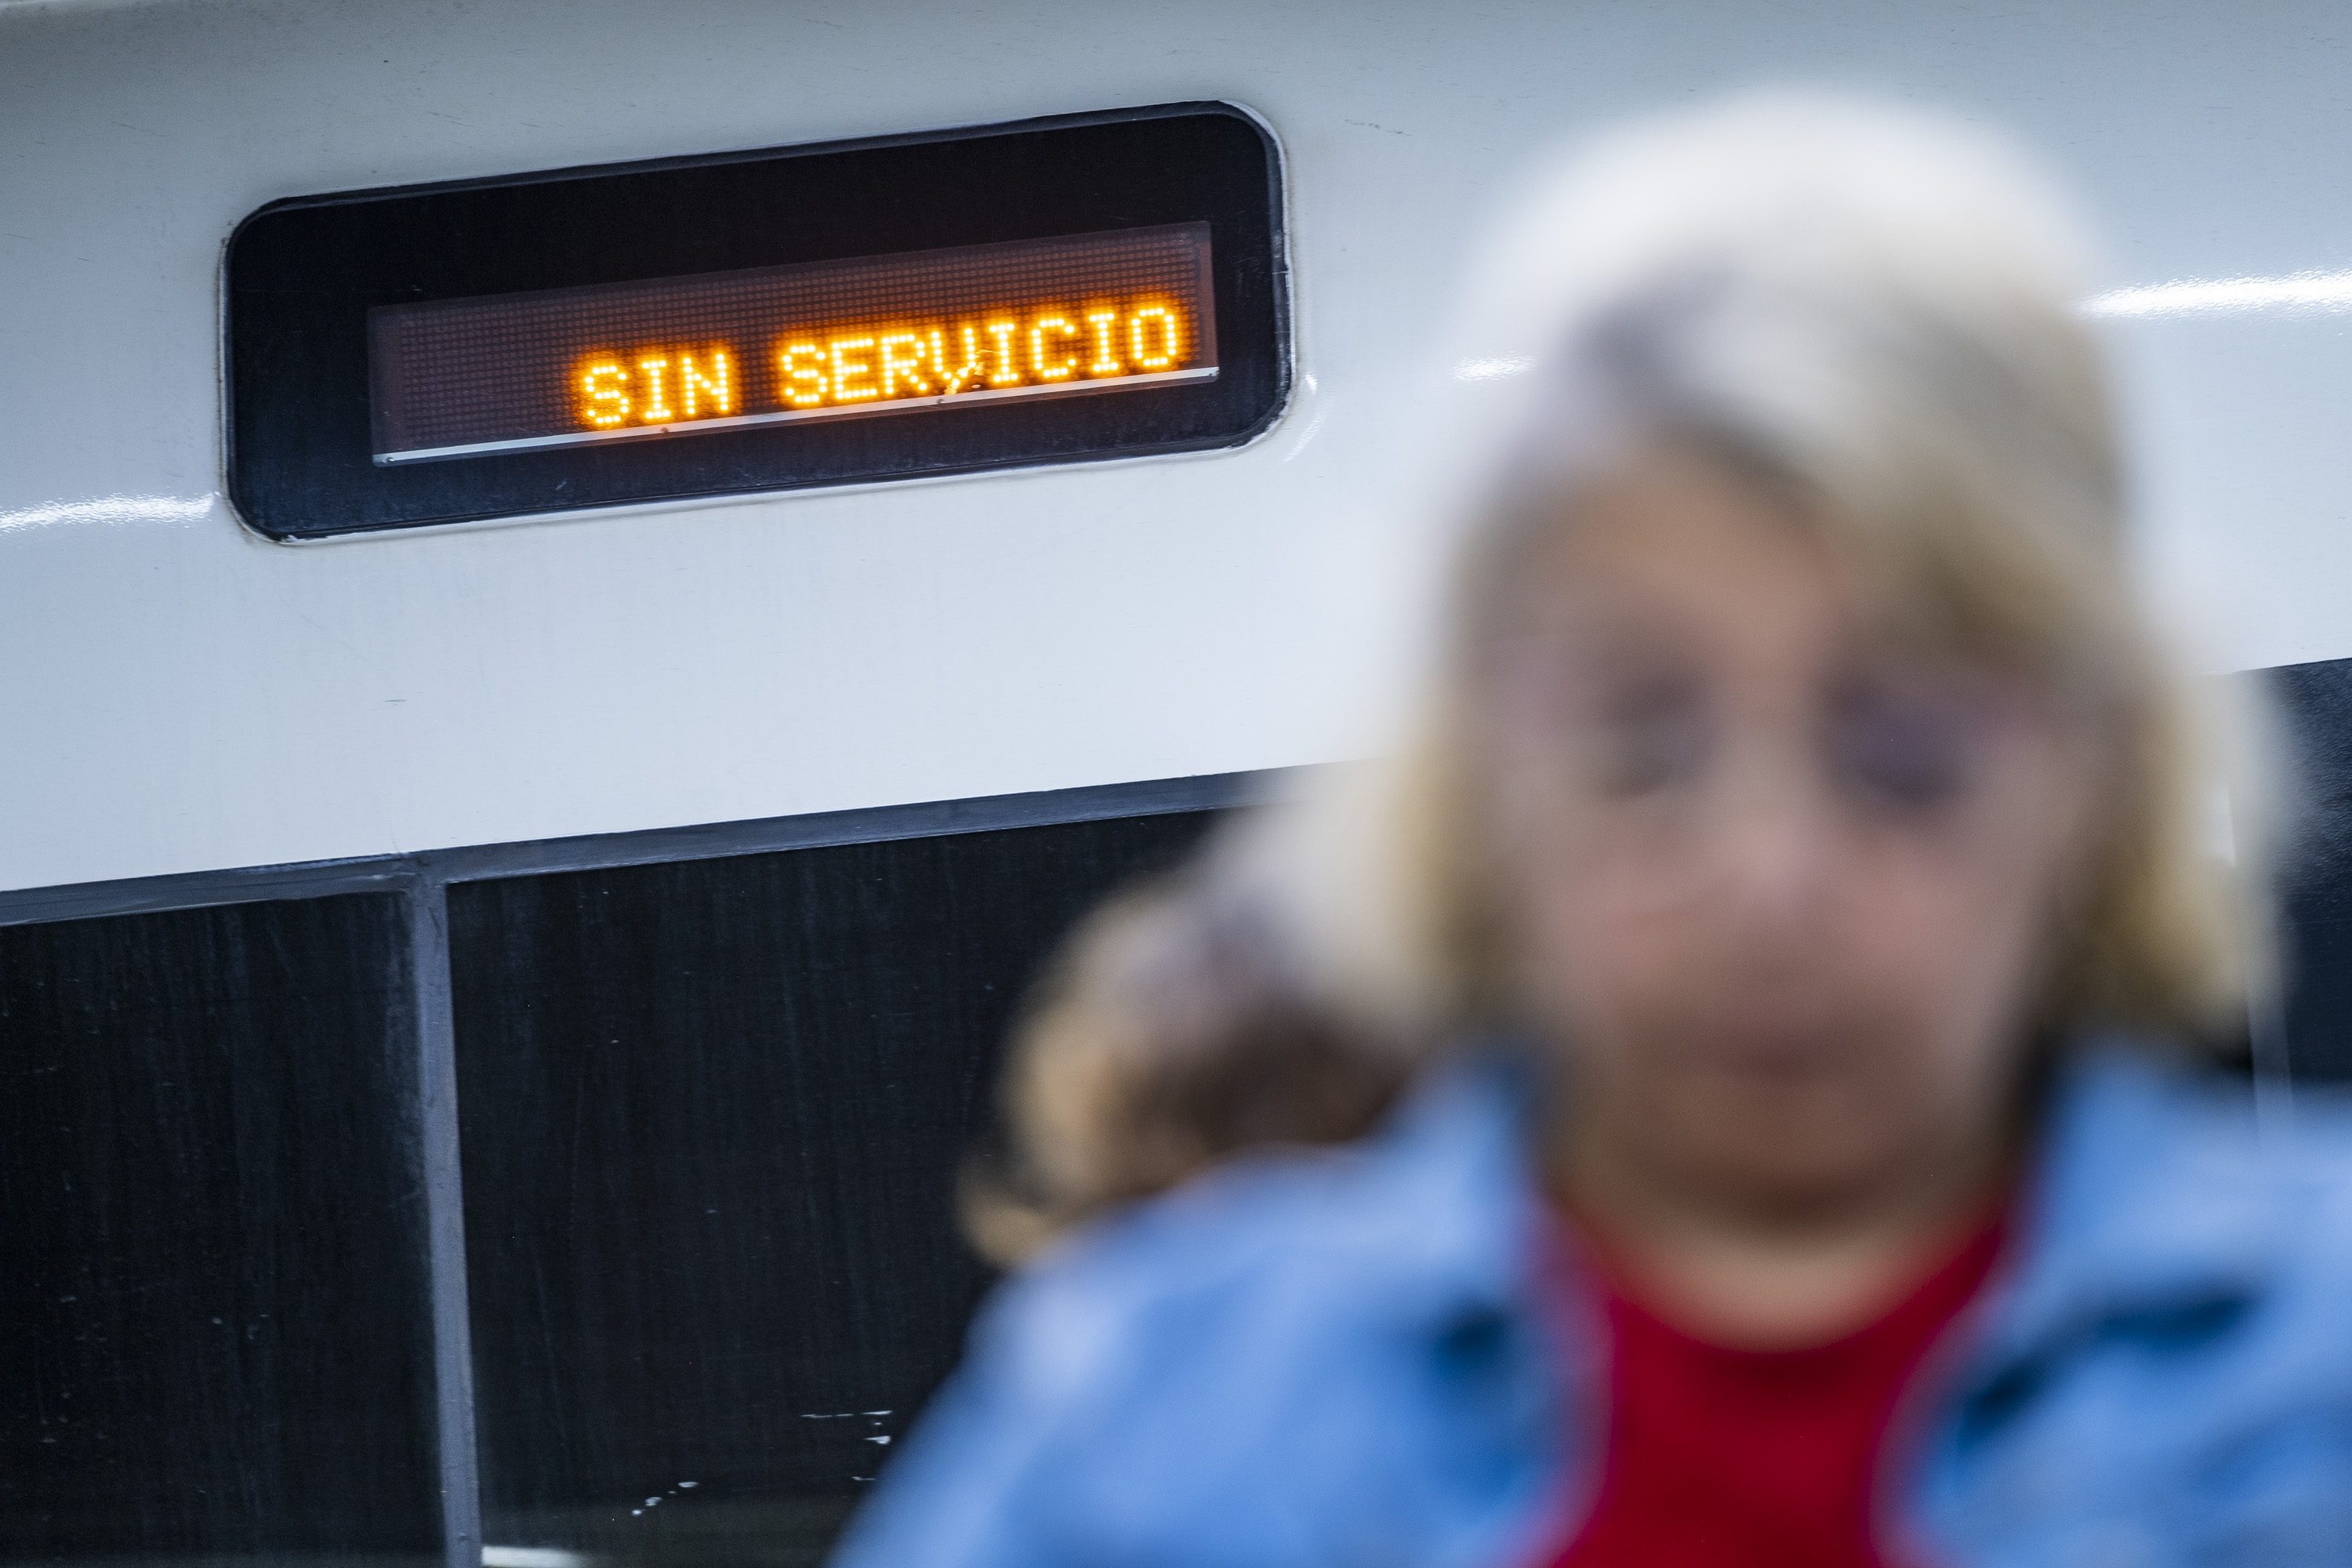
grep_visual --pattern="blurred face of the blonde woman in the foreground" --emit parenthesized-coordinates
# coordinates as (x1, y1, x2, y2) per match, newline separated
(1475, 456, 2098, 1213)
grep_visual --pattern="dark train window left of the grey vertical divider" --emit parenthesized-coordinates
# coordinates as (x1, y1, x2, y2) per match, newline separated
(0, 893, 440, 1563)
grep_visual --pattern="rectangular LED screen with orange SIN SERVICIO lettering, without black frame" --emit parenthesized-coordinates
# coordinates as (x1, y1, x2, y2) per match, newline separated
(369, 223, 1216, 463)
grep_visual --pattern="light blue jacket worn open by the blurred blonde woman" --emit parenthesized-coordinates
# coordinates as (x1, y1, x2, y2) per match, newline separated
(837, 1051, 2352, 1568)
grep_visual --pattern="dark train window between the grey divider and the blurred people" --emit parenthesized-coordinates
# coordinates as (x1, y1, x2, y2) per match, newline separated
(449, 813, 1207, 1568)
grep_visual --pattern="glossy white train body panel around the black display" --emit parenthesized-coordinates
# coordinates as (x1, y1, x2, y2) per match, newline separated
(0, 0, 2352, 886)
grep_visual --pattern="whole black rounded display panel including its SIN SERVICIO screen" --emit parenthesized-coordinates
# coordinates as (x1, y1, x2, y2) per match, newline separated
(226, 103, 1289, 539)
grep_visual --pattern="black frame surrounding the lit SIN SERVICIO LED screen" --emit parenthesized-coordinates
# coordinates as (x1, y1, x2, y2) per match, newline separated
(226, 103, 1291, 541)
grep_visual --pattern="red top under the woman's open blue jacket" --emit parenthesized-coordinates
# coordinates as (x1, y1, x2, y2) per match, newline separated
(1550, 1215, 2002, 1568)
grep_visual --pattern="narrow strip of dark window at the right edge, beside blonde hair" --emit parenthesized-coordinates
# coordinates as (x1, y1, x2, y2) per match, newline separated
(2270, 659, 2352, 1081)
